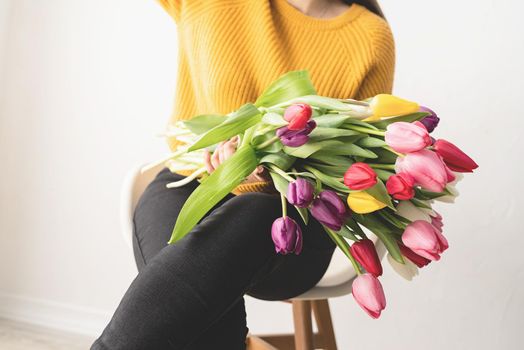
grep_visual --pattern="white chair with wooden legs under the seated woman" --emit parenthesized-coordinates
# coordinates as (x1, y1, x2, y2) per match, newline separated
(120, 165, 386, 350)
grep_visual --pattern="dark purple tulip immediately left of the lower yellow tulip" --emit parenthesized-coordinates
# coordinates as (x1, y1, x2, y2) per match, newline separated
(309, 190, 349, 231)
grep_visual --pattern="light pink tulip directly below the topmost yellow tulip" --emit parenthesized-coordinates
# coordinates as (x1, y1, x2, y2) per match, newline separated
(385, 122, 431, 153)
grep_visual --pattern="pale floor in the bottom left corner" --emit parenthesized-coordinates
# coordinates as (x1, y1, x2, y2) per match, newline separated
(0, 319, 94, 350)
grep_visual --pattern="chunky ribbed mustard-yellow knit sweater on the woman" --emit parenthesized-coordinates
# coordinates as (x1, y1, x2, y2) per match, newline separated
(157, 0, 395, 195)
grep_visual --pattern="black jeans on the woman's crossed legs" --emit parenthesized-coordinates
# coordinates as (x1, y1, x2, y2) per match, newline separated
(91, 169, 335, 350)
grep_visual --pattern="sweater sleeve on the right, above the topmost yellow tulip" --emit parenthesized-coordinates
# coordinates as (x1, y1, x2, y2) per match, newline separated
(354, 20, 395, 100)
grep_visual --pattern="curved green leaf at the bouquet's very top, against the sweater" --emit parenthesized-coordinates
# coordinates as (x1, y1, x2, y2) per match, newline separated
(255, 70, 317, 107)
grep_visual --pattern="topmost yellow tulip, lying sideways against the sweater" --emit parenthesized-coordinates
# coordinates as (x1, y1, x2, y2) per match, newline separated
(364, 94, 420, 121)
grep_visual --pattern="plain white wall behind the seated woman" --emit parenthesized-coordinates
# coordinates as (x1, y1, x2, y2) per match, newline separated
(0, 0, 524, 350)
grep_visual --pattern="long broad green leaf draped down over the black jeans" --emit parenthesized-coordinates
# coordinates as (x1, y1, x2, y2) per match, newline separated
(168, 145, 258, 244)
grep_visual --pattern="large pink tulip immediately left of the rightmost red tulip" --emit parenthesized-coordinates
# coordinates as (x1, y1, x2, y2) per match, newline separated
(395, 149, 448, 192)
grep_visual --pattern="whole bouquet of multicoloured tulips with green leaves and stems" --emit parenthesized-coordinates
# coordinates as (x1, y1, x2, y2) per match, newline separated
(144, 71, 477, 318)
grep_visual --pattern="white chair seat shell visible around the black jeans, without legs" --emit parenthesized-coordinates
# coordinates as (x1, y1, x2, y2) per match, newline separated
(120, 165, 386, 300)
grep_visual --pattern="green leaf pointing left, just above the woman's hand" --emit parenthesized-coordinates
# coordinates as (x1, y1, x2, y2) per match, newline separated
(187, 103, 262, 152)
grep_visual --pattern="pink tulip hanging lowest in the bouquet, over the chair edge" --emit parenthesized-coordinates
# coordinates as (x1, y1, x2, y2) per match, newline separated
(351, 273, 386, 318)
